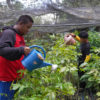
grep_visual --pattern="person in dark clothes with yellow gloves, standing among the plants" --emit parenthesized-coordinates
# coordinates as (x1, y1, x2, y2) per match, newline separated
(71, 31, 90, 91)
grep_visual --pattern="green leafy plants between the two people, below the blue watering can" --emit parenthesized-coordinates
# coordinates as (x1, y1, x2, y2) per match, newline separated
(13, 36, 77, 100)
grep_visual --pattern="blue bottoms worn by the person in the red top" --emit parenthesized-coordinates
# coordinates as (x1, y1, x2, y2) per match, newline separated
(0, 81, 15, 100)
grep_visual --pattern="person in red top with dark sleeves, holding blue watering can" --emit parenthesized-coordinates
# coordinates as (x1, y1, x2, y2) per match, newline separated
(0, 15, 33, 100)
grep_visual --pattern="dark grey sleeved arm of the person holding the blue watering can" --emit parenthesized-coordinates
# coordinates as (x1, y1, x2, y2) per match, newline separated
(0, 29, 24, 61)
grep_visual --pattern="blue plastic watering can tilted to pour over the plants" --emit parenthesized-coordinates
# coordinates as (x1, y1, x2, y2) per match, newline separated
(22, 45, 52, 71)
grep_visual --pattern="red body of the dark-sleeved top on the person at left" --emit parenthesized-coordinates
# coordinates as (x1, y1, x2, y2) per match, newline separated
(0, 28, 25, 81)
